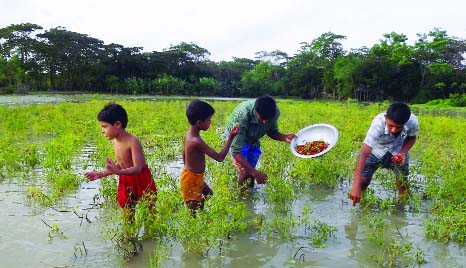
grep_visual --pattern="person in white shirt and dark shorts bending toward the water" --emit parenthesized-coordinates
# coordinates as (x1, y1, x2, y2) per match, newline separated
(349, 102, 419, 206)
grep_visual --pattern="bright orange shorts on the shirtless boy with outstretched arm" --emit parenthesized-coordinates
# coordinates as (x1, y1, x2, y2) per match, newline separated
(180, 168, 204, 202)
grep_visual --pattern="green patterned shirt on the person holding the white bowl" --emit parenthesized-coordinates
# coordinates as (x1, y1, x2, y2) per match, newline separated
(225, 100, 280, 153)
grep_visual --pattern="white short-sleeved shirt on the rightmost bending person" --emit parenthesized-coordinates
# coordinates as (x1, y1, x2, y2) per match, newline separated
(364, 113, 419, 159)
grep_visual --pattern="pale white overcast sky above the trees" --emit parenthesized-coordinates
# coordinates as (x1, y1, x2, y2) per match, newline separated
(0, 0, 466, 61)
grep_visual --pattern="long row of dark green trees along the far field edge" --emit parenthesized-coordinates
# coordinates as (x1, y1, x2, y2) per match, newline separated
(0, 23, 466, 102)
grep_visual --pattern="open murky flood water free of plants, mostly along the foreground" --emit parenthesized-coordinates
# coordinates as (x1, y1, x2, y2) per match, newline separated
(0, 96, 466, 268)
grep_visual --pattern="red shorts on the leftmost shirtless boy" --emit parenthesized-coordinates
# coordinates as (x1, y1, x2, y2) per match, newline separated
(117, 165, 157, 208)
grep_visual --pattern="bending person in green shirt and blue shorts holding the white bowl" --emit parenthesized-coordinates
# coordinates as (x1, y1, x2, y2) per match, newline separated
(225, 95, 296, 188)
